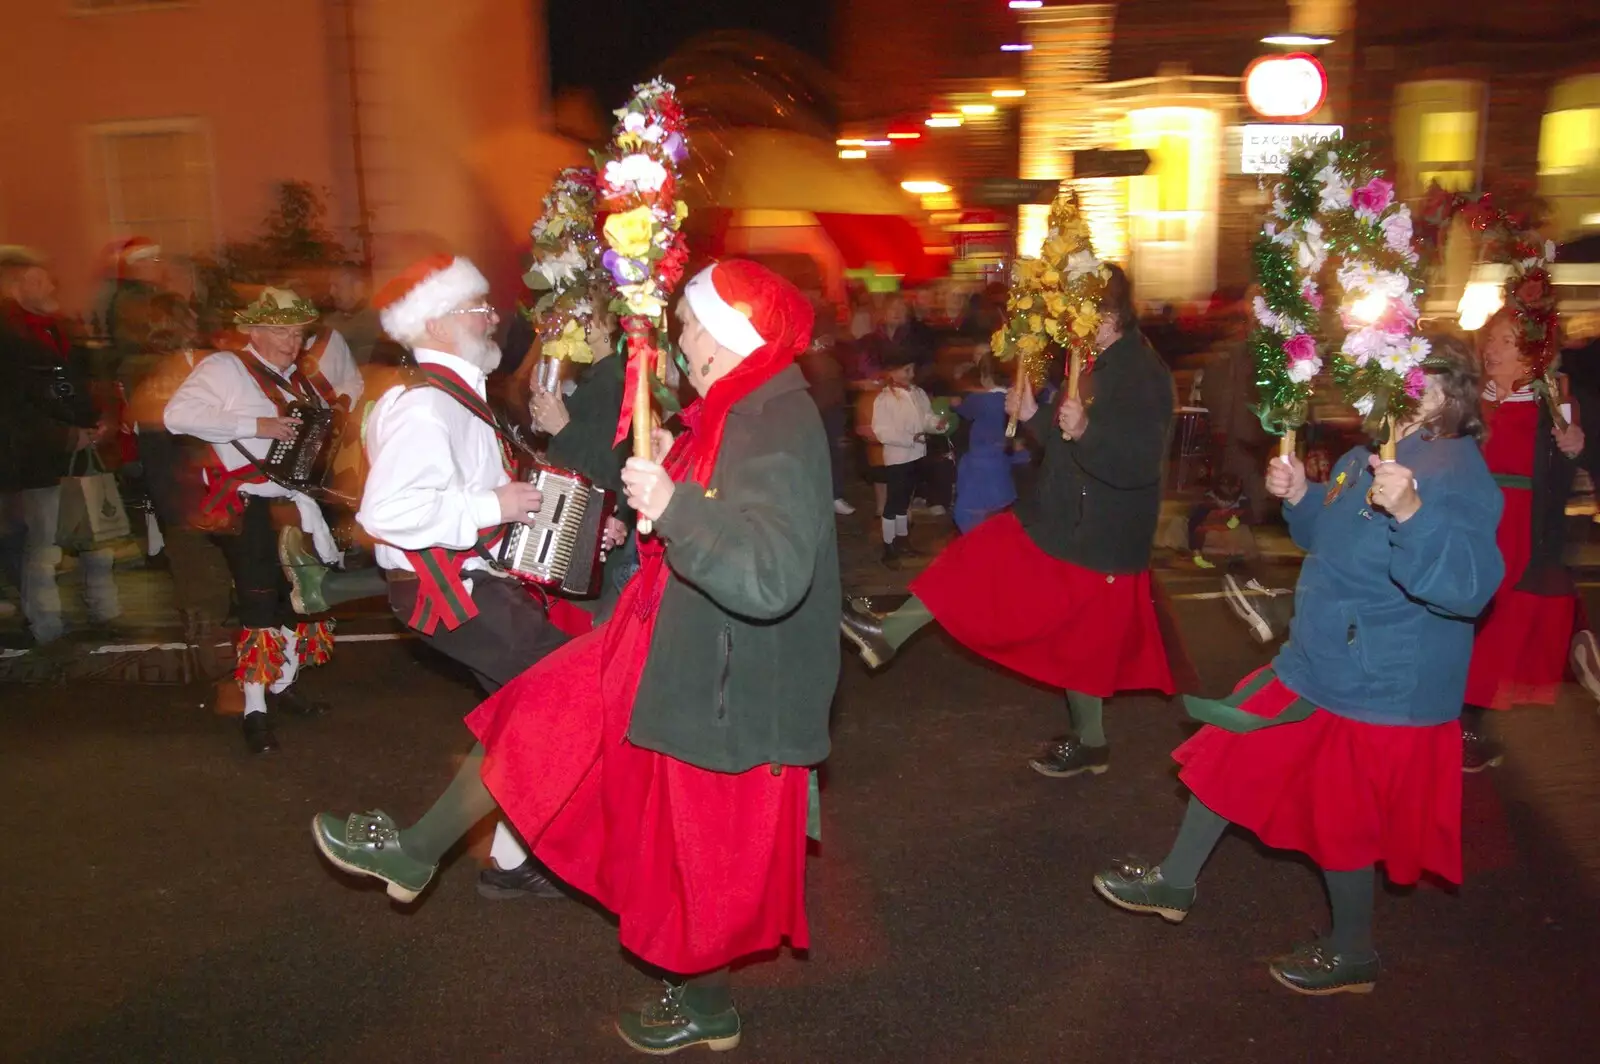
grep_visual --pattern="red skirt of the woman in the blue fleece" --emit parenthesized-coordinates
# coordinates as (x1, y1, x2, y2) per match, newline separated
(1173, 677, 1461, 883)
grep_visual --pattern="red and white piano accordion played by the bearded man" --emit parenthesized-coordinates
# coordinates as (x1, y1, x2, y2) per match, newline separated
(498, 466, 616, 598)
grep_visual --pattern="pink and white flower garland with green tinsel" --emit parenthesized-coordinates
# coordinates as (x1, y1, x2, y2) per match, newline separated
(1251, 139, 1430, 461)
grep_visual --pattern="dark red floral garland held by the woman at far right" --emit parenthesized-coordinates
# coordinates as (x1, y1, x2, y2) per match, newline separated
(1419, 181, 1566, 429)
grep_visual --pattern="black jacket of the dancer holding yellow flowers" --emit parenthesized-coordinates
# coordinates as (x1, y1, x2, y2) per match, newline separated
(1018, 331, 1173, 573)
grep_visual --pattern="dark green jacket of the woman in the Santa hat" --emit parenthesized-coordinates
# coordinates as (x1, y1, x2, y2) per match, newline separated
(629, 366, 840, 773)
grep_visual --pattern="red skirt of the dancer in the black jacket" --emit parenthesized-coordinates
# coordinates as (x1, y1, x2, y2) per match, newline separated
(910, 514, 1173, 698)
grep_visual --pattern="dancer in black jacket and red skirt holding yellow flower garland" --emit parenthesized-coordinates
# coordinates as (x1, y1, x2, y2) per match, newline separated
(842, 266, 1173, 778)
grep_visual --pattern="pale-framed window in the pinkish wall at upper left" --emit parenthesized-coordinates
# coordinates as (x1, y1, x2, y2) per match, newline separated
(93, 118, 216, 254)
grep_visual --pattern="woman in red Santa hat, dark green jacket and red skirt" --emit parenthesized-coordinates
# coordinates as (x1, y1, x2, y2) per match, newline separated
(312, 261, 838, 1053)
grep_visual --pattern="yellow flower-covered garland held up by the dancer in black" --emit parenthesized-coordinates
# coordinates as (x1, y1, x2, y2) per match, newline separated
(990, 192, 1110, 437)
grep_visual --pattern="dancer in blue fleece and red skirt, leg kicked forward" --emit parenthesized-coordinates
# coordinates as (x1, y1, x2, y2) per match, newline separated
(1094, 336, 1502, 995)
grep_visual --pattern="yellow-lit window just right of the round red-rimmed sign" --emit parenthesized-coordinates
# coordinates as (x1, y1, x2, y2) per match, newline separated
(1394, 80, 1483, 198)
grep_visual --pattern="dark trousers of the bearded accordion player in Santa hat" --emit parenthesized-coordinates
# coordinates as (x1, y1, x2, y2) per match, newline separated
(389, 570, 568, 694)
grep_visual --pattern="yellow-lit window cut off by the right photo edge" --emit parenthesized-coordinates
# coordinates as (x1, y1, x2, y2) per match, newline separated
(1539, 74, 1600, 238)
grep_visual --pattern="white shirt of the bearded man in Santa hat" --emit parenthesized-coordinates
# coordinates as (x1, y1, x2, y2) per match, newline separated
(355, 349, 510, 570)
